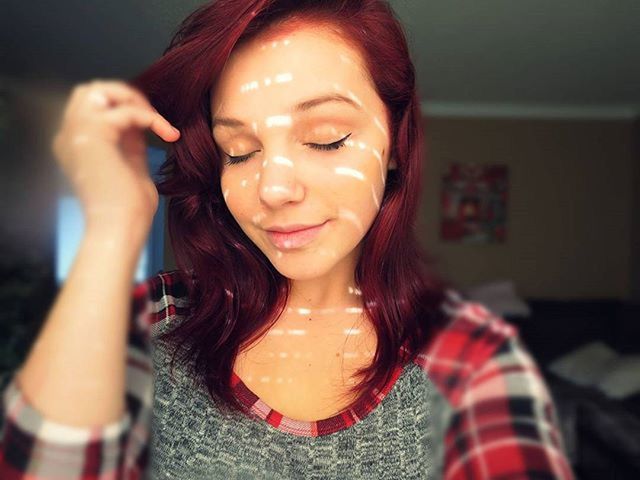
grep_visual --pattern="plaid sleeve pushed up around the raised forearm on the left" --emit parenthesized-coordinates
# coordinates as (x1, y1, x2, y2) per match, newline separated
(0, 279, 153, 480)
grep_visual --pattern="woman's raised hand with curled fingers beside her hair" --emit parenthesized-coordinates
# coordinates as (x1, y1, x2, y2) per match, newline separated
(52, 80, 180, 235)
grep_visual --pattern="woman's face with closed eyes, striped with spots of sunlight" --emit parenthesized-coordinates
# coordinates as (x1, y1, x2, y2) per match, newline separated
(211, 28, 394, 280)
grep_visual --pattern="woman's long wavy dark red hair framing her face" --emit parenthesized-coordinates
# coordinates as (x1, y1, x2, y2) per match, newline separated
(129, 0, 450, 418)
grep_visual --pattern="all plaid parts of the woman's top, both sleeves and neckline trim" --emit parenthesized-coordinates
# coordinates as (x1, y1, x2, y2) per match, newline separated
(0, 272, 574, 480)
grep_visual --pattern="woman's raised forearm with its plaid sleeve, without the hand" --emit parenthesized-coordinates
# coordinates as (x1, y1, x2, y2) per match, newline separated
(0, 228, 156, 479)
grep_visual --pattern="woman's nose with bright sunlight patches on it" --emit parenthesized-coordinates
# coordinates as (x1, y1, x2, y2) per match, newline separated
(258, 155, 304, 208)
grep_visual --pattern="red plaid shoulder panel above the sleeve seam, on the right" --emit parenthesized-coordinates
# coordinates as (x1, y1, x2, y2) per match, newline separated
(415, 290, 524, 405)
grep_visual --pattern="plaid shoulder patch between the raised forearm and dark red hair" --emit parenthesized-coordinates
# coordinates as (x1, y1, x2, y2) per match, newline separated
(131, 270, 189, 338)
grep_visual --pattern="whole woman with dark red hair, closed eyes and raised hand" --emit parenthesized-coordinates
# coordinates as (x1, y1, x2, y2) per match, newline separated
(0, 0, 573, 479)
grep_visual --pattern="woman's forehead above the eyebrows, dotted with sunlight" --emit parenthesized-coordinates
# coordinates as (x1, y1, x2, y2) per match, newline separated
(211, 27, 376, 117)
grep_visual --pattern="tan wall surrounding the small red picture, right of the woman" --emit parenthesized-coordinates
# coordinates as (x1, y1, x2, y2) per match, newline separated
(419, 118, 640, 299)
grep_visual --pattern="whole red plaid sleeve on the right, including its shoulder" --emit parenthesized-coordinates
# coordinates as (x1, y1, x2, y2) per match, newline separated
(430, 302, 575, 480)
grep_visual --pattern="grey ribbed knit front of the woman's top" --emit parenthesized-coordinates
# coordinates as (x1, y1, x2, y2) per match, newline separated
(151, 314, 451, 480)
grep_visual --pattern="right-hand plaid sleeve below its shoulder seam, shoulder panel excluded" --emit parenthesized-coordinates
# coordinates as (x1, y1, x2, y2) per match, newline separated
(443, 334, 575, 480)
